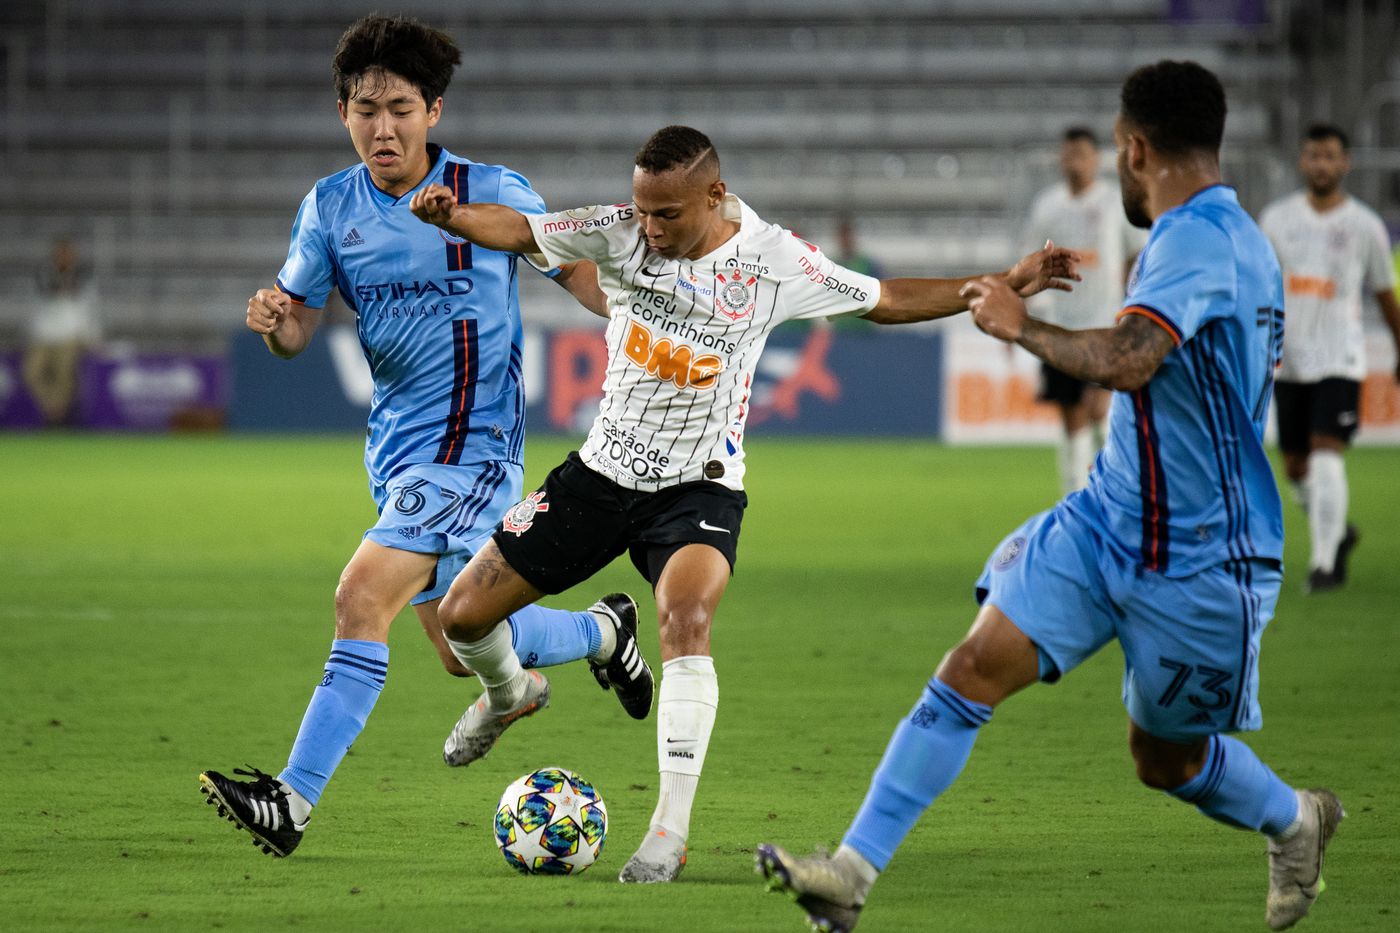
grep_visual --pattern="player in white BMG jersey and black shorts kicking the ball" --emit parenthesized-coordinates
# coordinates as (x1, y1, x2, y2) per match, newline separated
(413, 126, 1074, 883)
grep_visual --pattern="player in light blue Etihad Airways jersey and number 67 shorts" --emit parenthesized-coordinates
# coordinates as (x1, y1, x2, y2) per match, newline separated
(200, 15, 652, 856)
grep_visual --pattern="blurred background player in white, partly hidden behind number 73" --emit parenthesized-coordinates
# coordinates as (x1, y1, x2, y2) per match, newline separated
(1023, 126, 1147, 493)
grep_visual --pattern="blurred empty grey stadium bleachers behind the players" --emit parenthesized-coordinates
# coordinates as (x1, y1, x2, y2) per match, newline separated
(0, 0, 1287, 333)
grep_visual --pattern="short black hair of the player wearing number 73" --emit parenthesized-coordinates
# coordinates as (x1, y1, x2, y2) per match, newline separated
(1121, 62, 1225, 156)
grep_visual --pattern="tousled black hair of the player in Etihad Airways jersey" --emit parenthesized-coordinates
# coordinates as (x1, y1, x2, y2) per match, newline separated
(330, 14, 462, 106)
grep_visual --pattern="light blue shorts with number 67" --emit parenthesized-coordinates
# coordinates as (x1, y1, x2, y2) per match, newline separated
(364, 459, 524, 605)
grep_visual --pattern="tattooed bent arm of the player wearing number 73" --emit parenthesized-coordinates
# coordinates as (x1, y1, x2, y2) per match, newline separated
(963, 279, 1176, 391)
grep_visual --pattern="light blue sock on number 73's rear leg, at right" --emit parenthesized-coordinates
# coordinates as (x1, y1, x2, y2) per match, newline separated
(1168, 735, 1298, 836)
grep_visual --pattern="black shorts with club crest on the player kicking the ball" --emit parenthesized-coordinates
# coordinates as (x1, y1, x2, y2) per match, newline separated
(493, 451, 749, 593)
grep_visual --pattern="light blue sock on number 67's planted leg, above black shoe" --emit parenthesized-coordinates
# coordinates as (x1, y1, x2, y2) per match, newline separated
(277, 639, 389, 806)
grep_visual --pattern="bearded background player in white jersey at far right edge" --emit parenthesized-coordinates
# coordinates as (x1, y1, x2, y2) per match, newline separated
(1259, 123, 1400, 593)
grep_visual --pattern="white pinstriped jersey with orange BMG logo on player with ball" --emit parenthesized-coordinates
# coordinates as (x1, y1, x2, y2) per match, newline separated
(528, 195, 879, 490)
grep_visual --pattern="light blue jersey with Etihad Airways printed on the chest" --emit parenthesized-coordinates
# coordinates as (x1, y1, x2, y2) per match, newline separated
(277, 146, 545, 487)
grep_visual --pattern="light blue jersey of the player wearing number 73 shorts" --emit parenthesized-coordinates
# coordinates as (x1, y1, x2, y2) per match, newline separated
(1067, 185, 1284, 577)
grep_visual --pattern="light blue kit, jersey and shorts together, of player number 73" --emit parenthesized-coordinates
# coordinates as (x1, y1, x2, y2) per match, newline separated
(977, 185, 1284, 741)
